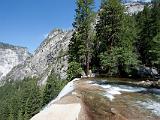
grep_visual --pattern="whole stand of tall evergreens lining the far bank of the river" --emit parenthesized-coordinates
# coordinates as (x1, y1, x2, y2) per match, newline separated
(68, 0, 160, 79)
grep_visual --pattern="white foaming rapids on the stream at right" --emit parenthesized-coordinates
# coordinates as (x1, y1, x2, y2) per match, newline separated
(88, 80, 160, 116)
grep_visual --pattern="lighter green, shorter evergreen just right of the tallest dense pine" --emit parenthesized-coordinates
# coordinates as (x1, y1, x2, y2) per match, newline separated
(117, 15, 139, 76)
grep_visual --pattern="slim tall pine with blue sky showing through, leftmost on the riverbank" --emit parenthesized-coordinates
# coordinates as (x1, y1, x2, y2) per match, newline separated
(69, 0, 94, 75)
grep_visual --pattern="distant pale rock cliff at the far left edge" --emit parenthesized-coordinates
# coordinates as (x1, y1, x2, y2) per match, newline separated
(0, 42, 31, 80)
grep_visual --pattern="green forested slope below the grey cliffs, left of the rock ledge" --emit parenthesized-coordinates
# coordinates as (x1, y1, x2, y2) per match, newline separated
(0, 73, 66, 120)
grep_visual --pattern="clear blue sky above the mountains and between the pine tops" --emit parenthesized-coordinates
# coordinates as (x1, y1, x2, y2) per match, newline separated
(0, 0, 101, 53)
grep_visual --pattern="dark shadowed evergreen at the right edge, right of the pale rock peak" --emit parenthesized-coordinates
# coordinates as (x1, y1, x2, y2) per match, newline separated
(137, 0, 160, 67)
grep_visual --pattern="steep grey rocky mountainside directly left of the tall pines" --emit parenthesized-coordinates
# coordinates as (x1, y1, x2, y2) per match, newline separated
(2, 29, 73, 84)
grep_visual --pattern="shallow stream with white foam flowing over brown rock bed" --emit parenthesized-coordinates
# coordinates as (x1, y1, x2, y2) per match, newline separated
(91, 79, 160, 120)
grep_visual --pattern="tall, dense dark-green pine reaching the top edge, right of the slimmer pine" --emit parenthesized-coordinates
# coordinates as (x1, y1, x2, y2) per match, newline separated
(96, 0, 124, 75)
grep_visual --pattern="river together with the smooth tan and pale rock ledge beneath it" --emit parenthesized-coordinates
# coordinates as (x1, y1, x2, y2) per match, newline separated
(32, 78, 160, 120)
